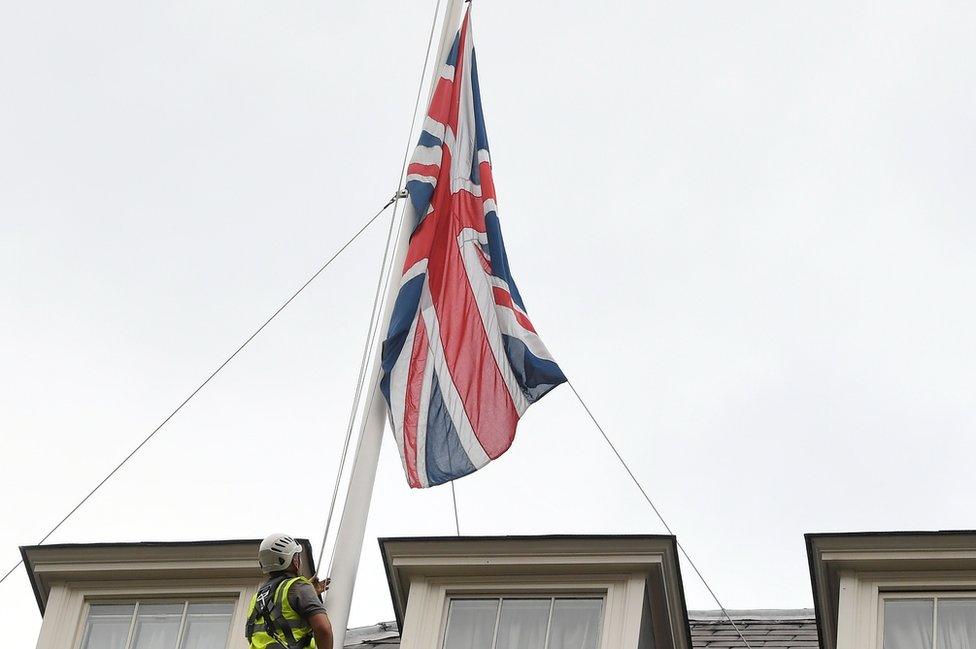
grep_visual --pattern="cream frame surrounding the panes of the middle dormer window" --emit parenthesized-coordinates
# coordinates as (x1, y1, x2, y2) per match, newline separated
(401, 573, 645, 649)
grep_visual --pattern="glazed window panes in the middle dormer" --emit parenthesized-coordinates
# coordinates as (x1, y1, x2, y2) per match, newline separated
(443, 596, 603, 649)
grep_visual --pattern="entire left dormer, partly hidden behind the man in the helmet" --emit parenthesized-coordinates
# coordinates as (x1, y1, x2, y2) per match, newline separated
(21, 540, 314, 649)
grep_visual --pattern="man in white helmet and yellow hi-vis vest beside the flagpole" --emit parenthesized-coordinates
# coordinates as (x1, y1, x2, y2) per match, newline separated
(244, 534, 332, 649)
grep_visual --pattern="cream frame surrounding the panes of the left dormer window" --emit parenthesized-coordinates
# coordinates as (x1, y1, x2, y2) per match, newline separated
(37, 579, 259, 649)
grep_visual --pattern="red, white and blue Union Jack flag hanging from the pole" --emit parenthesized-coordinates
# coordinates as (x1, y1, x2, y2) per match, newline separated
(380, 9, 566, 488)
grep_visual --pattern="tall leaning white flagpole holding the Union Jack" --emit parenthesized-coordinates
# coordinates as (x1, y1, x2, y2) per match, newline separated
(325, 0, 464, 649)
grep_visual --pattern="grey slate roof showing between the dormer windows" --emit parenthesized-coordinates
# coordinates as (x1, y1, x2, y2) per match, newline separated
(345, 608, 820, 649)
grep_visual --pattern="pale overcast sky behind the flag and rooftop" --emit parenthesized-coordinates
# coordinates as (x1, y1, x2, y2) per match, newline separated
(0, 0, 976, 646)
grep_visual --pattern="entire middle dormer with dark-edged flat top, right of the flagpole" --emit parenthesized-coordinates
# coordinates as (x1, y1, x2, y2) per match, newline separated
(380, 536, 691, 649)
